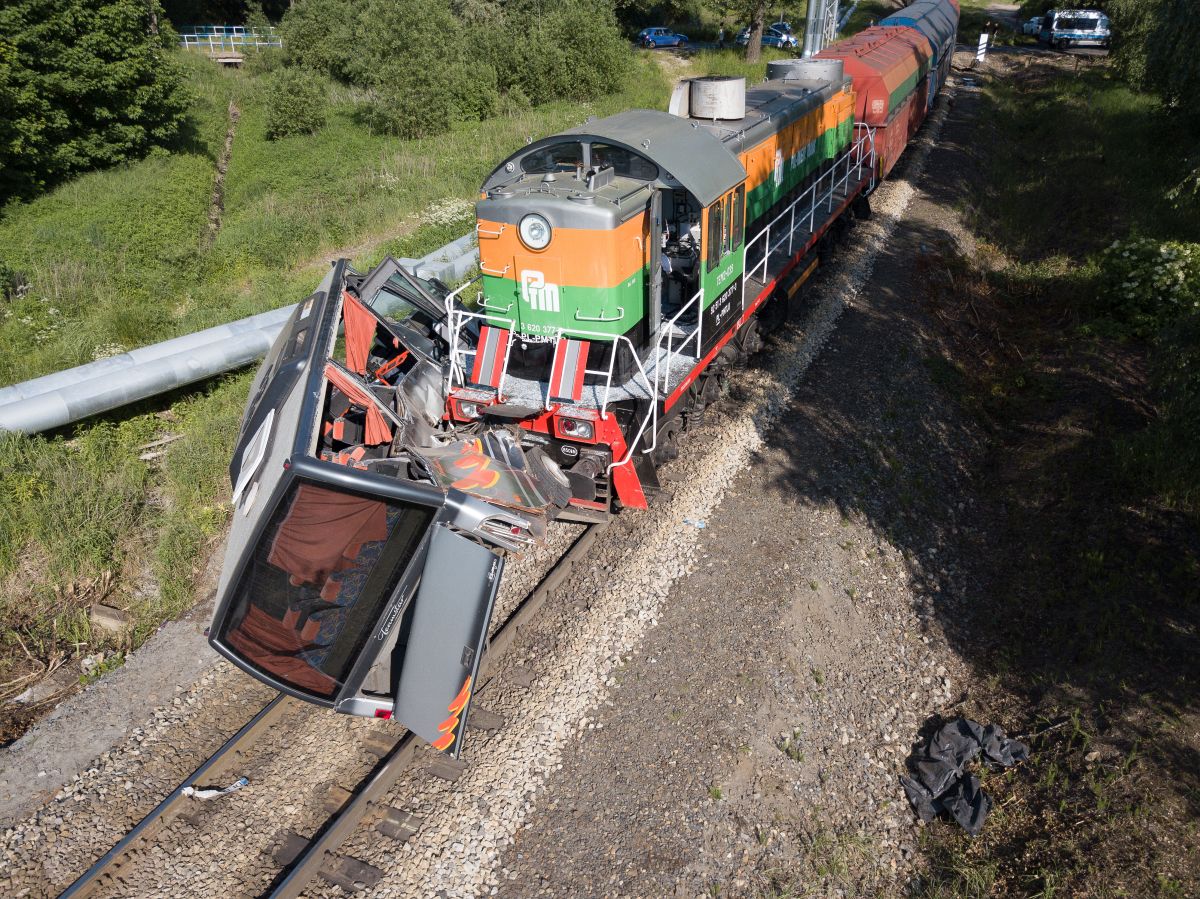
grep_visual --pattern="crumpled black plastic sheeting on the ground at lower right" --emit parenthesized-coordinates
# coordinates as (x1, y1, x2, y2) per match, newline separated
(900, 718, 1030, 837)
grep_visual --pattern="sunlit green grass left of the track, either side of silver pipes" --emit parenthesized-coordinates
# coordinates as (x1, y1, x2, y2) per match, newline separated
(0, 47, 668, 695)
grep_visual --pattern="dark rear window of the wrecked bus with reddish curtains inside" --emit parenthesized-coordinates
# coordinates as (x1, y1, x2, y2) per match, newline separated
(218, 480, 434, 699)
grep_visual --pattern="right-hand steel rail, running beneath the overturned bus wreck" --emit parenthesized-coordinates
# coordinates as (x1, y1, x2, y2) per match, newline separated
(270, 522, 608, 899)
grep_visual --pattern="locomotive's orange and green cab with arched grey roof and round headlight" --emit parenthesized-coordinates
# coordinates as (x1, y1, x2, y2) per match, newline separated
(476, 110, 745, 379)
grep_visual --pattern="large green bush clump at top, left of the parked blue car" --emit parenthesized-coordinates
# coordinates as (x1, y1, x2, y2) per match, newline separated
(280, 0, 632, 138)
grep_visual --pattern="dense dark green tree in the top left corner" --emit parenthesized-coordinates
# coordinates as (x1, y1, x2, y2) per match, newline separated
(0, 0, 187, 202)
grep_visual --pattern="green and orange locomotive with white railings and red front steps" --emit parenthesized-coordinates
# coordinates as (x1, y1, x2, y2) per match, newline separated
(450, 60, 874, 520)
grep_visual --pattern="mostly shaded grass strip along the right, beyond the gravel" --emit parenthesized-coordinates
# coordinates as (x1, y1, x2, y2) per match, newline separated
(919, 54, 1200, 897)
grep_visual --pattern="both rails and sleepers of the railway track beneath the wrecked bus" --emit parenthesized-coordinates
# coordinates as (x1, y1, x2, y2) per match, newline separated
(60, 523, 608, 899)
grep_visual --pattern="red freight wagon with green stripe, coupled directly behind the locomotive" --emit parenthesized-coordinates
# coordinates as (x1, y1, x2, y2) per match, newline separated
(817, 26, 934, 175)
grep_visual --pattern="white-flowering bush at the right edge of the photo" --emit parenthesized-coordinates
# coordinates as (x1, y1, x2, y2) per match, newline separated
(1099, 238, 1200, 336)
